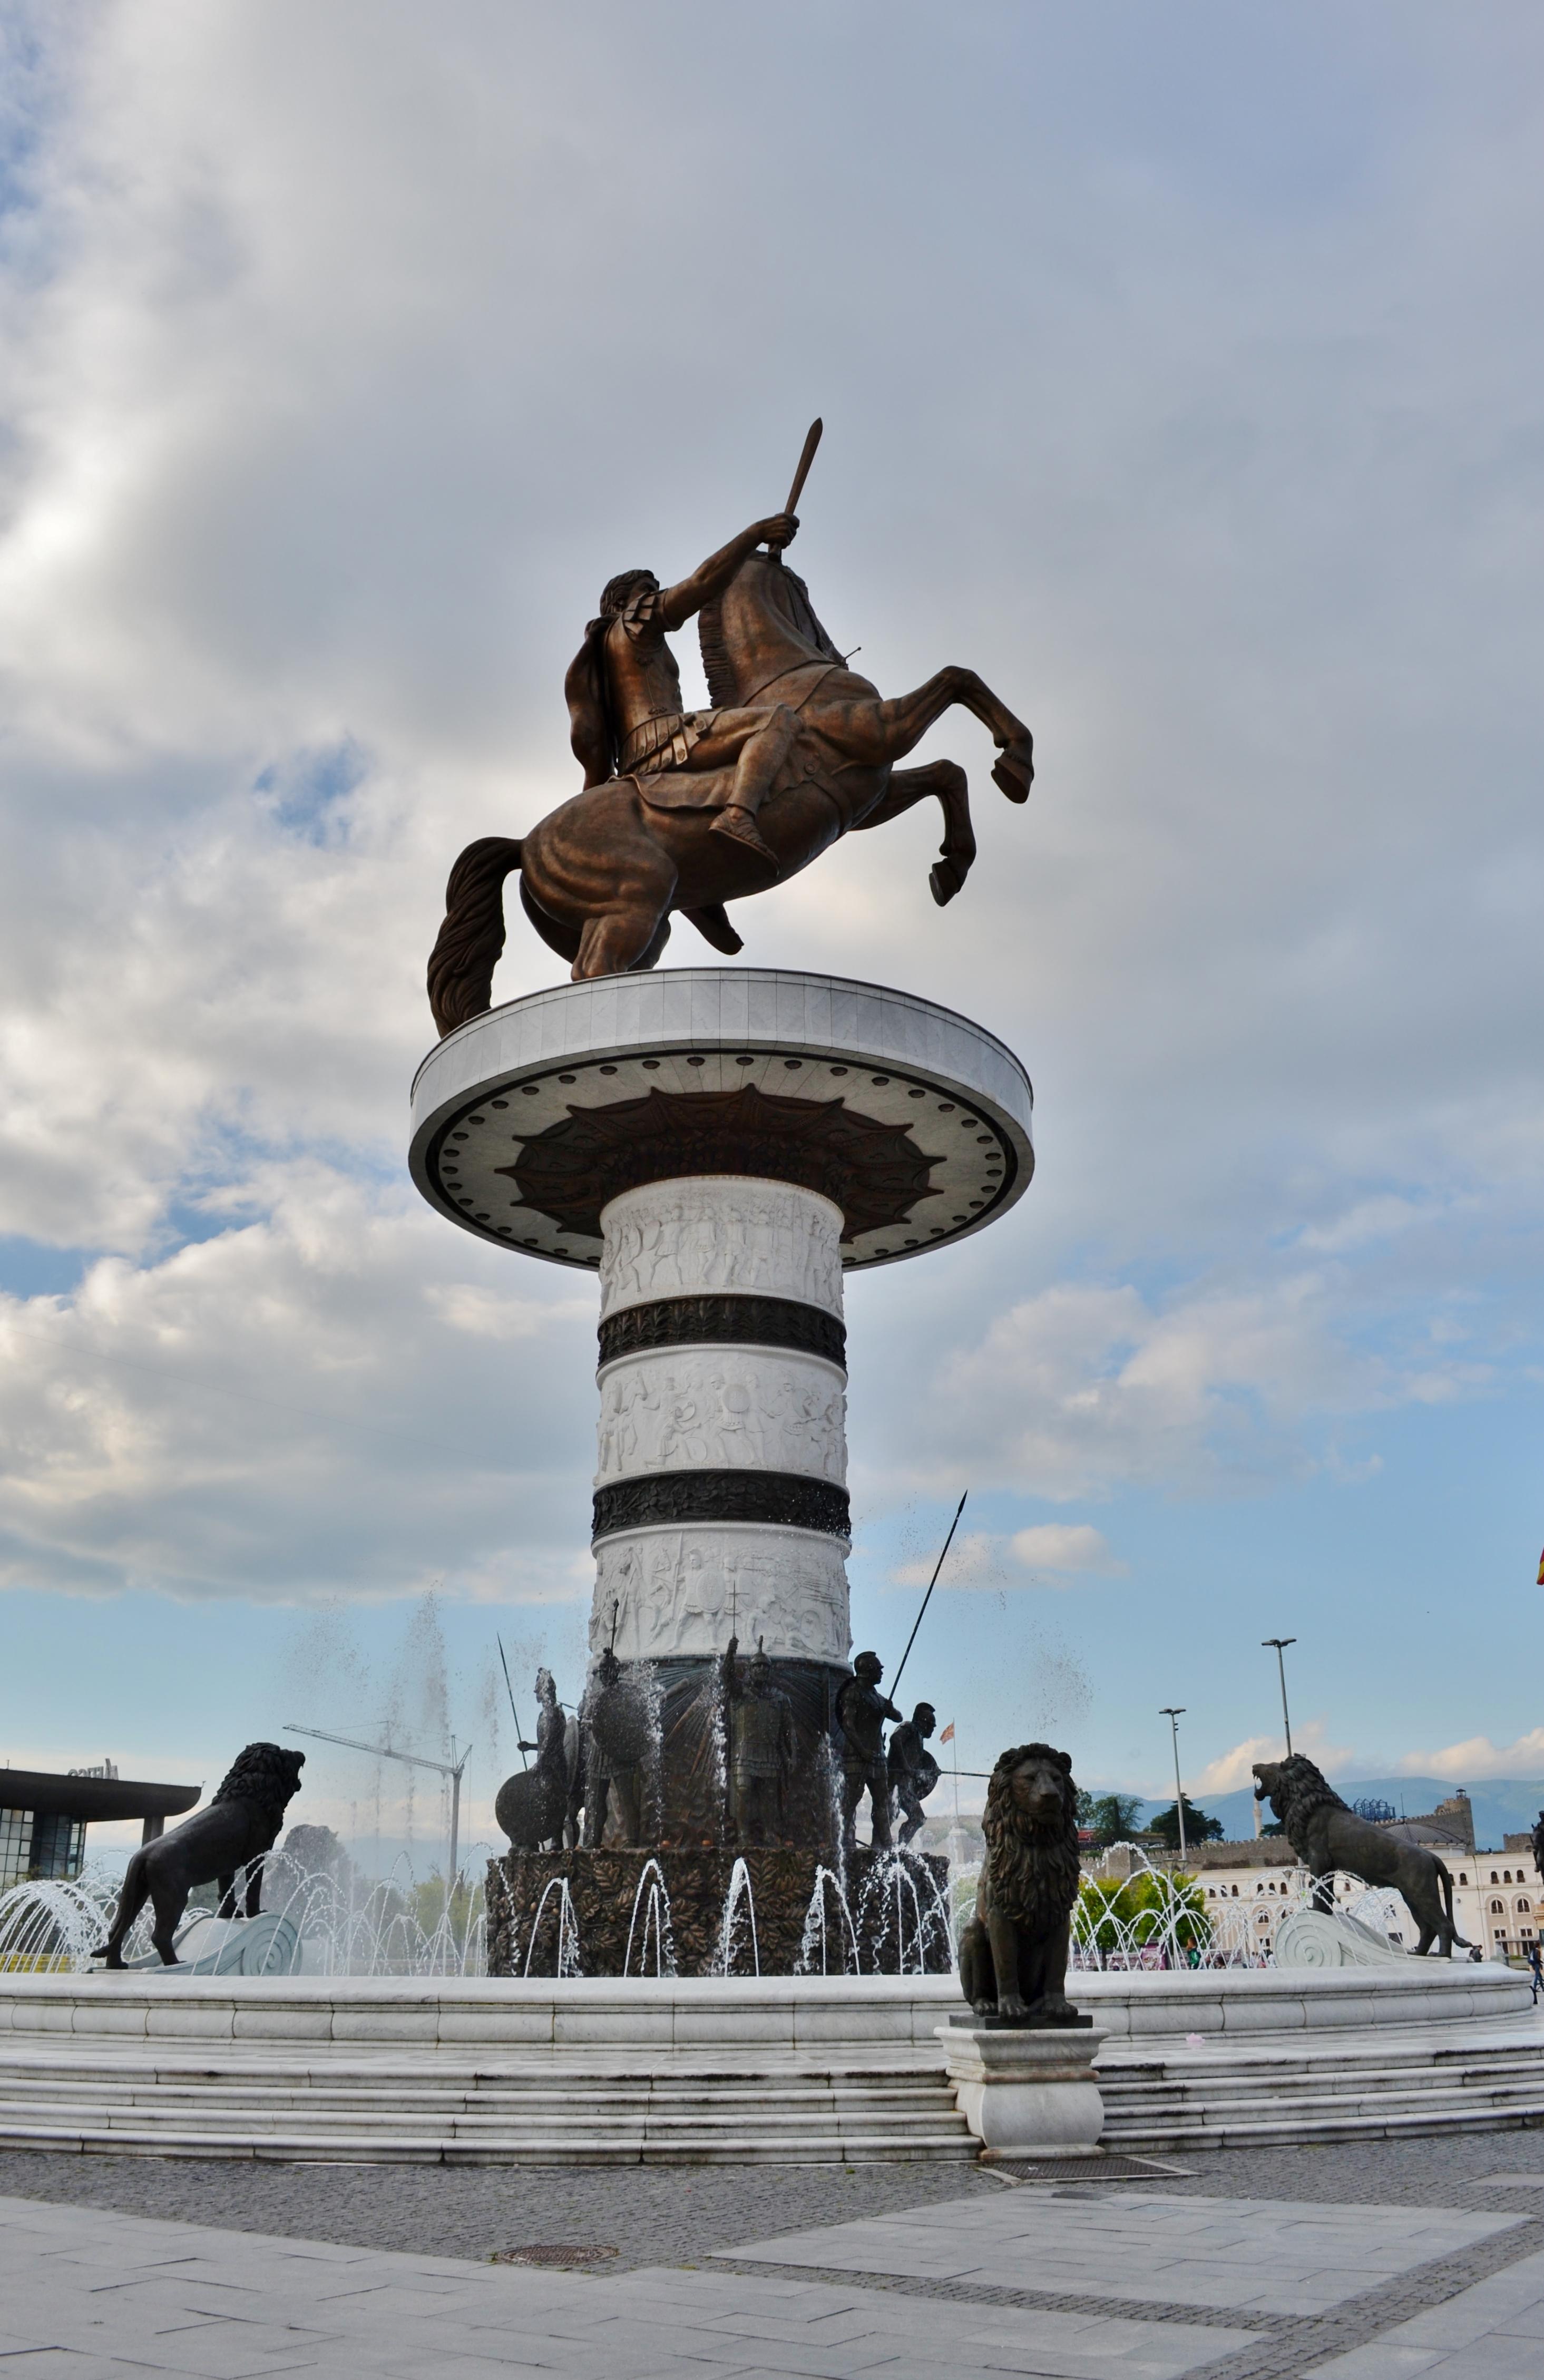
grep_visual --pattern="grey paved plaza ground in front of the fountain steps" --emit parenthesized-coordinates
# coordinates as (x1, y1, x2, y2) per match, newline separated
(0, 2132, 1544, 2380)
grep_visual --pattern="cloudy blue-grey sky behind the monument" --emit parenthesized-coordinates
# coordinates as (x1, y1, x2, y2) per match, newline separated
(0, 0, 1544, 1856)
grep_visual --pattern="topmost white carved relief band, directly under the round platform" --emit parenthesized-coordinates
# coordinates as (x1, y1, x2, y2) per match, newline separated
(600, 1176, 842, 1314)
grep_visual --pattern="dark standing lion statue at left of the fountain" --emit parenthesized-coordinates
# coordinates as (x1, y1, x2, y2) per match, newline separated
(91, 1744, 305, 1966)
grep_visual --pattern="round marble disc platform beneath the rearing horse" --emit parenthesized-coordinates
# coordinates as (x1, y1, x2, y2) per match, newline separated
(409, 966, 1035, 1269)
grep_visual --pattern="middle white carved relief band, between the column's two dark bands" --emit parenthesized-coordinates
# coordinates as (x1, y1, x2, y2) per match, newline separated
(595, 1347, 847, 1488)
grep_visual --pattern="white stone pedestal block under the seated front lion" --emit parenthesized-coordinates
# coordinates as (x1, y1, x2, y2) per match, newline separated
(935, 2025, 1104, 2166)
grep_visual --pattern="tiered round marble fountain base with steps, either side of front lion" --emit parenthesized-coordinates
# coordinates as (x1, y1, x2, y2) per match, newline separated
(0, 1959, 1544, 2166)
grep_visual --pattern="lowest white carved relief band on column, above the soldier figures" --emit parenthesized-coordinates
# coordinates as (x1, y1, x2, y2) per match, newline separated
(590, 1521, 852, 1661)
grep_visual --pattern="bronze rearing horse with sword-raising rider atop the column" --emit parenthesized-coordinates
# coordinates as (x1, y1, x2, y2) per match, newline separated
(428, 424, 1035, 1035)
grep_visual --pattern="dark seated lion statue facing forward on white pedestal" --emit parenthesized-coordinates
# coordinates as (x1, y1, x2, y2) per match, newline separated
(959, 1744, 1092, 2025)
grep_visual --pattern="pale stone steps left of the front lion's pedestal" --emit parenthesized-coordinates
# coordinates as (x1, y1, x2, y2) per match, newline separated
(0, 2056, 975, 2163)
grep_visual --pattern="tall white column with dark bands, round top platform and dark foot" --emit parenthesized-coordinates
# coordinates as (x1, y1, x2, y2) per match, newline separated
(412, 966, 1035, 1971)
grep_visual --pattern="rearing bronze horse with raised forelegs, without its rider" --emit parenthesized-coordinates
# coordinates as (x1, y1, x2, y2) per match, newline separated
(428, 542, 1035, 1035)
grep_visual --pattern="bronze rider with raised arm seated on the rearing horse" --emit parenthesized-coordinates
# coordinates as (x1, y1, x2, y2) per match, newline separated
(564, 512, 799, 869)
